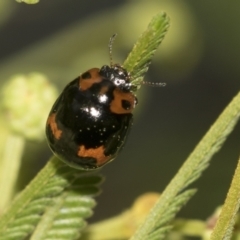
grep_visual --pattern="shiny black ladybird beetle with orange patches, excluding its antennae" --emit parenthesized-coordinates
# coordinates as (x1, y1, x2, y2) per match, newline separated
(46, 65, 137, 170)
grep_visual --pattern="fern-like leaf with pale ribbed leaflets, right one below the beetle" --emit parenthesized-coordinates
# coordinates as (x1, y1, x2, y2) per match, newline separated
(31, 175, 102, 240)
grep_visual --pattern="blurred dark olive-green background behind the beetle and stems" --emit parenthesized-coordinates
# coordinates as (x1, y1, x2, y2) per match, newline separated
(0, 0, 240, 220)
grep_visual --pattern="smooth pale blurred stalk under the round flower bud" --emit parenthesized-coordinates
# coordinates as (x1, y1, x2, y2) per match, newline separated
(0, 133, 25, 212)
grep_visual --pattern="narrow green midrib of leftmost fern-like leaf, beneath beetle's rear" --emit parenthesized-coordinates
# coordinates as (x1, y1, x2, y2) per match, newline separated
(0, 157, 65, 232)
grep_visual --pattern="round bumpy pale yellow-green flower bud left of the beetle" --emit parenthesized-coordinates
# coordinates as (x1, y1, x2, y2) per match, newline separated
(1, 73, 57, 140)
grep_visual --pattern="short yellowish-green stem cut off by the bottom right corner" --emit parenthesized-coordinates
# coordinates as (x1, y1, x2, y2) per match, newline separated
(210, 157, 240, 240)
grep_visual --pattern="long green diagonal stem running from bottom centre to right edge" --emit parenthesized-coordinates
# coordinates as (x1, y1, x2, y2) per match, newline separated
(131, 93, 240, 240)
